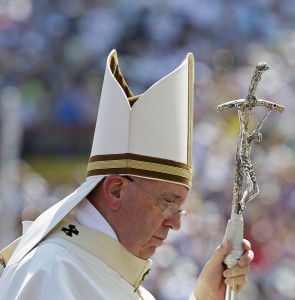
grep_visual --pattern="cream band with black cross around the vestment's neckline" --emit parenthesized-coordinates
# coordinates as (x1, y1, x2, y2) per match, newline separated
(49, 217, 152, 291)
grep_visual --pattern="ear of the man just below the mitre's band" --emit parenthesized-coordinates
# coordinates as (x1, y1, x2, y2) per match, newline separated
(103, 175, 125, 211)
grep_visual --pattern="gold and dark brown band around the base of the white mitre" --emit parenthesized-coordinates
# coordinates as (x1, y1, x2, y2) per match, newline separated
(87, 153, 192, 188)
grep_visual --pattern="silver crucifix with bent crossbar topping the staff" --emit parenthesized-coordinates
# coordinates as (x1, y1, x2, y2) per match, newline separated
(217, 62, 284, 214)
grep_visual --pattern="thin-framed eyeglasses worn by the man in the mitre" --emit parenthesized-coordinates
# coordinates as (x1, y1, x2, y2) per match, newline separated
(124, 176, 187, 219)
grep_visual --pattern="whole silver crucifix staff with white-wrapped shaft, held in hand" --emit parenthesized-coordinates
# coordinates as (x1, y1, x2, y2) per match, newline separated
(217, 62, 284, 300)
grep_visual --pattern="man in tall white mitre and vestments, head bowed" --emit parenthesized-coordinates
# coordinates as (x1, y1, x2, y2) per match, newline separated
(0, 50, 254, 300)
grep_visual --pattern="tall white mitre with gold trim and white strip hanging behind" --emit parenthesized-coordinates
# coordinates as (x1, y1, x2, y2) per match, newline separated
(7, 50, 194, 267)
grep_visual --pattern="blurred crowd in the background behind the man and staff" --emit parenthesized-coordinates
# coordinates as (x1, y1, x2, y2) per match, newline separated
(0, 0, 295, 300)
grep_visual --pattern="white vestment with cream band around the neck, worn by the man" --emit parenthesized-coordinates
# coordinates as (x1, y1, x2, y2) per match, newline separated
(0, 203, 199, 300)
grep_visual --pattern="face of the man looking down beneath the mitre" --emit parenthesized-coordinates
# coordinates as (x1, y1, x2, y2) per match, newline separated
(116, 178, 188, 259)
